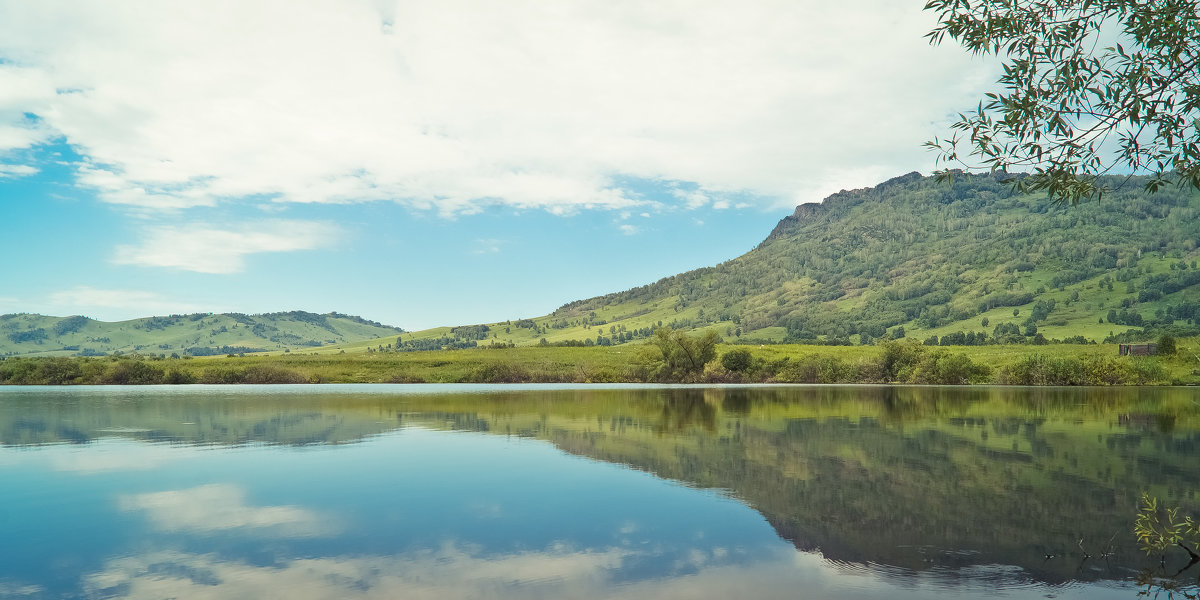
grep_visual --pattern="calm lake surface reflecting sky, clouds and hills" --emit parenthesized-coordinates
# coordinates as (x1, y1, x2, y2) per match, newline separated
(0, 385, 1200, 600)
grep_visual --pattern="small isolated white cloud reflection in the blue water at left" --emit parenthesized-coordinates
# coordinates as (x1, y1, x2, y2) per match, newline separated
(118, 484, 334, 536)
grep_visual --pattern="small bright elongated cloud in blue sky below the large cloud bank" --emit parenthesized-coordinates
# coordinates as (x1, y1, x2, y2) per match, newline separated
(113, 221, 340, 274)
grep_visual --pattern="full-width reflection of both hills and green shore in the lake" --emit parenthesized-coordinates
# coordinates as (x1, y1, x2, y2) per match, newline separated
(0, 386, 1200, 582)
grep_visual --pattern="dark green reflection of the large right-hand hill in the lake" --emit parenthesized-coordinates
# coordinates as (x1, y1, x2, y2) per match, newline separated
(472, 386, 1200, 581)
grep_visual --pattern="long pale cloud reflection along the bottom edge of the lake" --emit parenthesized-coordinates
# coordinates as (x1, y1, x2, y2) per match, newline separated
(83, 544, 1132, 600)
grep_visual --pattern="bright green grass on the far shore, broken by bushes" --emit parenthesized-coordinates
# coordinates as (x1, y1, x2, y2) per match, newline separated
(0, 338, 1200, 384)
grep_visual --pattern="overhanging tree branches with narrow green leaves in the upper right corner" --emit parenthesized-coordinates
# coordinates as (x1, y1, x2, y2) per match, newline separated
(925, 0, 1200, 204)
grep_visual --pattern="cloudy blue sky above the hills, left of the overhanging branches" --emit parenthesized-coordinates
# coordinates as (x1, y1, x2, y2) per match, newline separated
(0, 0, 997, 330)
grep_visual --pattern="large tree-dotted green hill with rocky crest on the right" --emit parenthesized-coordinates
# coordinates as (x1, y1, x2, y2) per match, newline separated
(388, 173, 1200, 350)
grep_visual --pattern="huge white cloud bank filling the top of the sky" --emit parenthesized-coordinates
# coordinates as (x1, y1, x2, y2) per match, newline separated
(0, 0, 992, 214)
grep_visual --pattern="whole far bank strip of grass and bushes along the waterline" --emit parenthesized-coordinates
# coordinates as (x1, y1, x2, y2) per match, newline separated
(0, 341, 1200, 385)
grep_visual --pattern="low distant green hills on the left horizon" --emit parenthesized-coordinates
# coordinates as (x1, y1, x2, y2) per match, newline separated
(0, 311, 403, 356)
